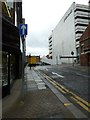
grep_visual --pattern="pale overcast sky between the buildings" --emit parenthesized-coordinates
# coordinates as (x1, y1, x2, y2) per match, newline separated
(22, 0, 88, 56)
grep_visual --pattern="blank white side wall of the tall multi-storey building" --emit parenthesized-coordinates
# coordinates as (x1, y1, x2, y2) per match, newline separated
(52, 4, 76, 64)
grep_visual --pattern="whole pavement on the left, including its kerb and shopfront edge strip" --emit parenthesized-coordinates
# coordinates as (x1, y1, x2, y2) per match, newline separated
(2, 66, 88, 120)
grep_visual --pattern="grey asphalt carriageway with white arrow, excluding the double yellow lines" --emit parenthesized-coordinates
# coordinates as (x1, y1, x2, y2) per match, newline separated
(35, 65, 90, 116)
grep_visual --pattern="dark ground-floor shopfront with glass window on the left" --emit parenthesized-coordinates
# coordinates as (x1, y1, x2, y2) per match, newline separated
(2, 15, 21, 97)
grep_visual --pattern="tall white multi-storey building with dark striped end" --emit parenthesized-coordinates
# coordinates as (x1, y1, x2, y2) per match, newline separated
(49, 2, 90, 64)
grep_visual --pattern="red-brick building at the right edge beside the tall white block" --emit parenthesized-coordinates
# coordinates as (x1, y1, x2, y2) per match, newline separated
(80, 24, 90, 66)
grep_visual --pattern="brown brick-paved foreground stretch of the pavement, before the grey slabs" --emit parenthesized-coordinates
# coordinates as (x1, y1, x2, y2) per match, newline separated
(3, 88, 73, 118)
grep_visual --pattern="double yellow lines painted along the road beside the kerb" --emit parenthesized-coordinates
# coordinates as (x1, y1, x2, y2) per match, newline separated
(44, 74, 90, 112)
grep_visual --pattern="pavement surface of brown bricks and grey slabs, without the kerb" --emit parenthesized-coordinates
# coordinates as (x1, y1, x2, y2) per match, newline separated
(3, 67, 74, 120)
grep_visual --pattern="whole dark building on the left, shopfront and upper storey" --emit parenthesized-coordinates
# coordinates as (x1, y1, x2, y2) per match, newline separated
(0, 1, 22, 97)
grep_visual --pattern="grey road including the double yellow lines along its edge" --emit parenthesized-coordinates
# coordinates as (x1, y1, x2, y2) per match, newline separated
(35, 65, 90, 114)
